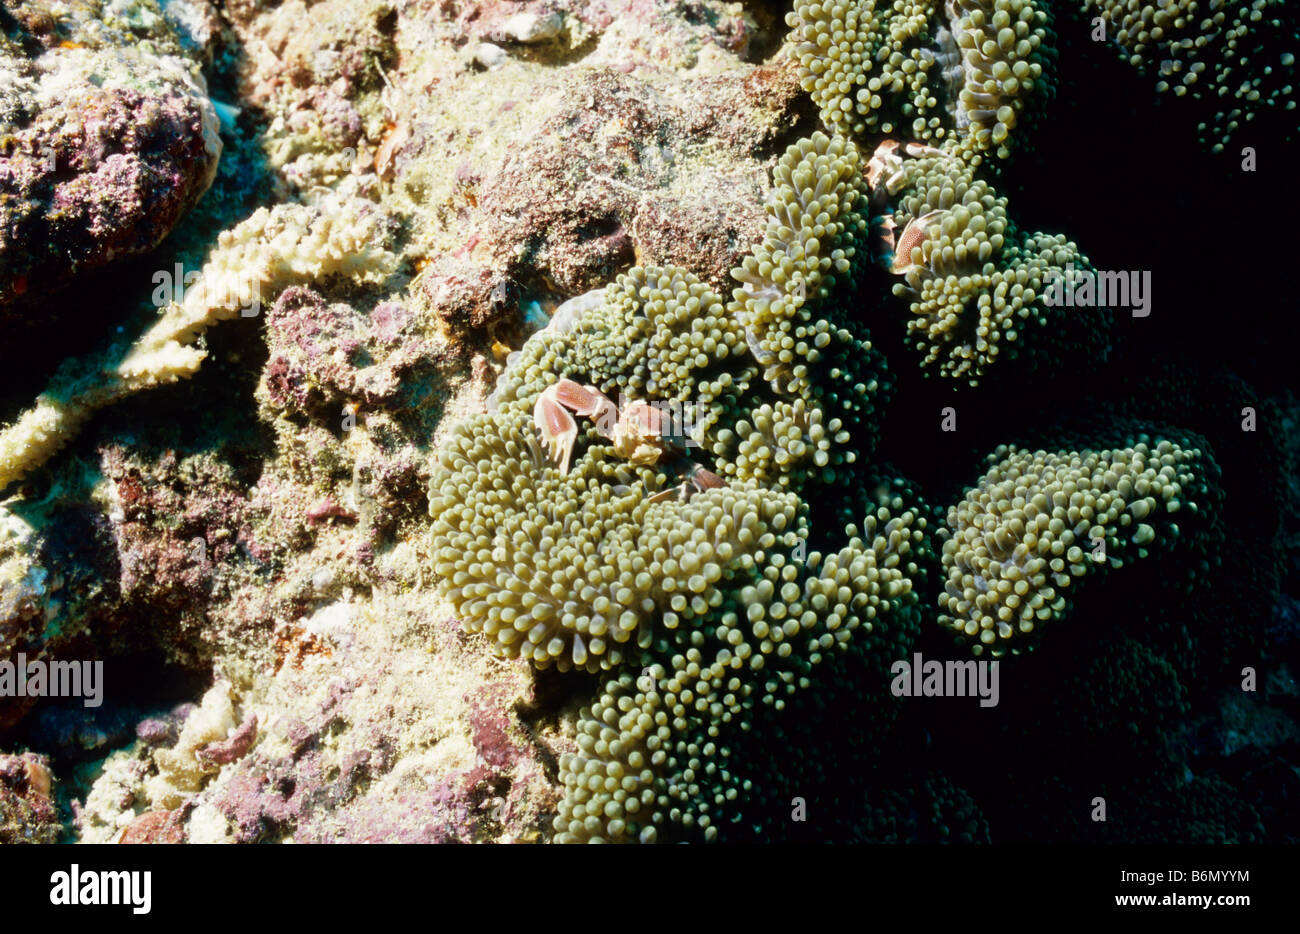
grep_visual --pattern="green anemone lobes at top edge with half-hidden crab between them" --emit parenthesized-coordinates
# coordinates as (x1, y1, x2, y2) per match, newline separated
(780, 0, 1112, 386)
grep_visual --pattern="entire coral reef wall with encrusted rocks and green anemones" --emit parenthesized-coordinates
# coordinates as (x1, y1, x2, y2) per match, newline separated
(0, 0, 1300, 858)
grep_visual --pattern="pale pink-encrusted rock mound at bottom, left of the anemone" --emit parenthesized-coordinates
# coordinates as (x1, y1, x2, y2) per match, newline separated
(79, 596, 558, 843)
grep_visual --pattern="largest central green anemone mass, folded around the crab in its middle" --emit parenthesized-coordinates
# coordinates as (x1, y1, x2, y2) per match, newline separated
(430, 128, 926, 842)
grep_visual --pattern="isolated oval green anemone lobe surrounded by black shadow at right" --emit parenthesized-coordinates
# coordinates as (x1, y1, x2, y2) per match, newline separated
(939, 436, 1213, 656)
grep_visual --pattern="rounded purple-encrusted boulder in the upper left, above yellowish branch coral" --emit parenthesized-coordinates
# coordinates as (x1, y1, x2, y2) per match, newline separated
(0, 34, 221, 316)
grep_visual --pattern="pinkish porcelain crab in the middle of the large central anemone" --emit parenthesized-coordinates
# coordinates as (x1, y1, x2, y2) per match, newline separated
(533, 379, 725, 502)
